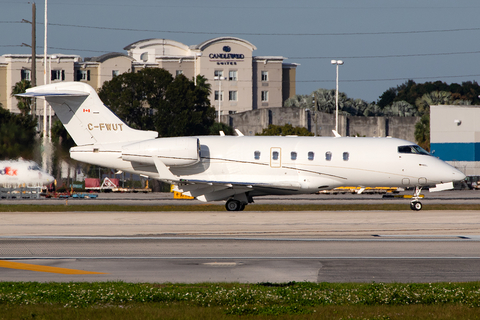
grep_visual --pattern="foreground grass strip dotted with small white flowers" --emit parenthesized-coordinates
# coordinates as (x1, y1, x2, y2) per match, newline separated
(0, 282, 480, 320)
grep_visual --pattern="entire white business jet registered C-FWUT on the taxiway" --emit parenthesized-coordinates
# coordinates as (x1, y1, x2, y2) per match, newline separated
(21, 82, 465, 211)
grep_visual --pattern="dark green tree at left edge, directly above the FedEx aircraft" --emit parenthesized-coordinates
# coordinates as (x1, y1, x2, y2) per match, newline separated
(0, 106, 37, 159)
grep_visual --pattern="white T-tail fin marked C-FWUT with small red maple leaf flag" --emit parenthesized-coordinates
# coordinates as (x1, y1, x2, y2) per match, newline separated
(18, 82, 158, 146)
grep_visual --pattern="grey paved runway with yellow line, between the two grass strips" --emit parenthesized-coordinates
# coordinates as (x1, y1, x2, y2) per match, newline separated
(0, 210, 480, 283)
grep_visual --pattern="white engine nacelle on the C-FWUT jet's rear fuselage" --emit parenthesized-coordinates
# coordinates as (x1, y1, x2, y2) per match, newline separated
(122, 137, 200, 167)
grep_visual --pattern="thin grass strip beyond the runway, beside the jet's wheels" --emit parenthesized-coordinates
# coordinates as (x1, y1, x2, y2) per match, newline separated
(0, 202, 480, 212)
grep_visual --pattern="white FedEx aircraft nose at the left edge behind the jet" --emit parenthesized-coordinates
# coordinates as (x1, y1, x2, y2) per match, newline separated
(0, 160, 54, 188)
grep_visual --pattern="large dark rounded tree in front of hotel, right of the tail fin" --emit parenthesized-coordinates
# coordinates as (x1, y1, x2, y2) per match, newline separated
(99, 68, 215, 137)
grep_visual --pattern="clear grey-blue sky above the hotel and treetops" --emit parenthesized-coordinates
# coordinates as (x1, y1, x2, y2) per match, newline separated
(0, 0, 480, 102)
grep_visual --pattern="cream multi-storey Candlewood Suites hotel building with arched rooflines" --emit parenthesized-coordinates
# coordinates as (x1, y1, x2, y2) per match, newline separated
(0, 37, 297, 115)
